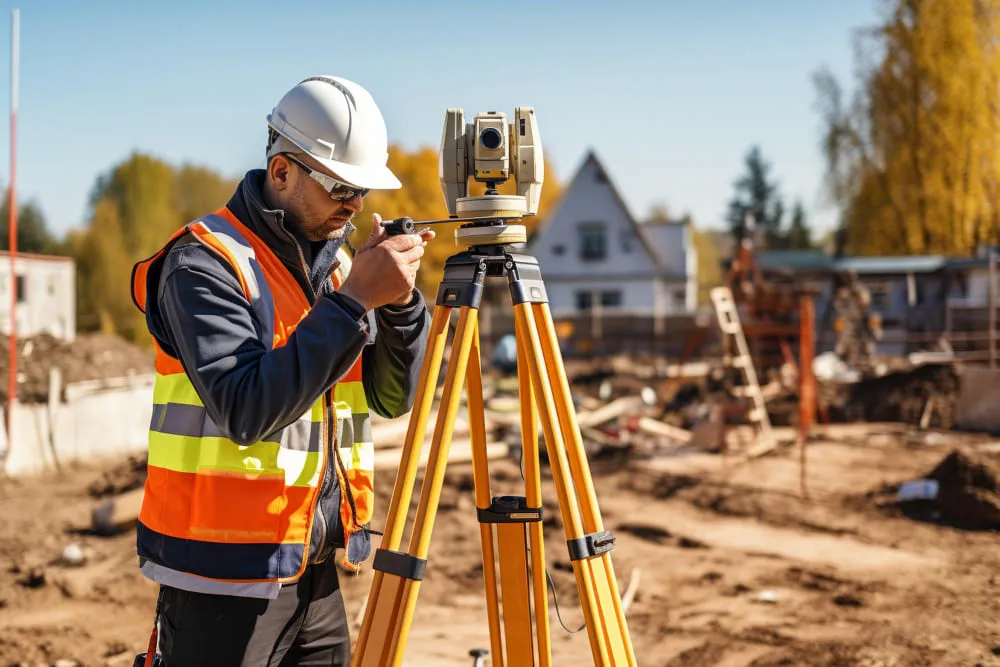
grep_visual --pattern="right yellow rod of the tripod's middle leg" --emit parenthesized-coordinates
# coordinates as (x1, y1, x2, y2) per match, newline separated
(515, 316, 552, 667)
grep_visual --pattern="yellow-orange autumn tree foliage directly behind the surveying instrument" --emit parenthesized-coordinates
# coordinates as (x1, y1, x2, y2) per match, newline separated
(360, 145, 562, 299)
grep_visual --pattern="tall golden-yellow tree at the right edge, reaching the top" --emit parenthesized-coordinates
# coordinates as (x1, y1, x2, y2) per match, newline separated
(814, 0, 1000, 254)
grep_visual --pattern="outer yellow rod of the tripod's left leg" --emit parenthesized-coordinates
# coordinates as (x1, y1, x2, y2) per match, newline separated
(352, 306, 452, 666)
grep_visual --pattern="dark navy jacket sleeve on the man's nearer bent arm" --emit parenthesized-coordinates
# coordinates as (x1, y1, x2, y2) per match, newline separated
(147, 244, 368, 444)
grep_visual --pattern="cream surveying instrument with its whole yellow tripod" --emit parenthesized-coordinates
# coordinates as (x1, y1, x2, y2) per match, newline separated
(351, 107, 636, 667)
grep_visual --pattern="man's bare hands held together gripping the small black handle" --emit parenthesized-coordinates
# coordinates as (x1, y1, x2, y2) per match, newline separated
(340, 213, 434, 310)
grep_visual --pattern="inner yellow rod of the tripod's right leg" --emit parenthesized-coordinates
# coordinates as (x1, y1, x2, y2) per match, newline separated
(514, 302, 614, 667)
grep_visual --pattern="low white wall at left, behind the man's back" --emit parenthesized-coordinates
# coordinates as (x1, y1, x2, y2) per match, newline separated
(0, 375, 155, 476)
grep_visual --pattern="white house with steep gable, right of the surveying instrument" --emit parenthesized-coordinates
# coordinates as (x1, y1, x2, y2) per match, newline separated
(528, 151, 697, 316)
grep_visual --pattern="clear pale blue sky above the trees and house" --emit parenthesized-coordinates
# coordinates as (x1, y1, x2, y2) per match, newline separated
(0, 0, 878, 233)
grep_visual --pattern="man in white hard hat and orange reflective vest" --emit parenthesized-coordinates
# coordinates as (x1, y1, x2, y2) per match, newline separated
(133, 76, 433, 667)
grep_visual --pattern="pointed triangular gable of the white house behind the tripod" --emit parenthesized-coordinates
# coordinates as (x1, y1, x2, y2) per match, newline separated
(530, 153, 660, 277)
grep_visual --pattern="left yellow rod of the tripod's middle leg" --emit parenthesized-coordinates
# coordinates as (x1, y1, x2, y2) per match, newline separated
(466, 320, 504, 667)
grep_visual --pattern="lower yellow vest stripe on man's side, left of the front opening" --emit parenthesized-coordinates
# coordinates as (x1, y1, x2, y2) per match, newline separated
(149, 431, 322, 486)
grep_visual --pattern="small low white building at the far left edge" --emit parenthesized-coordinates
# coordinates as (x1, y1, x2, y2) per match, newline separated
(0, 251, 76, 341)
